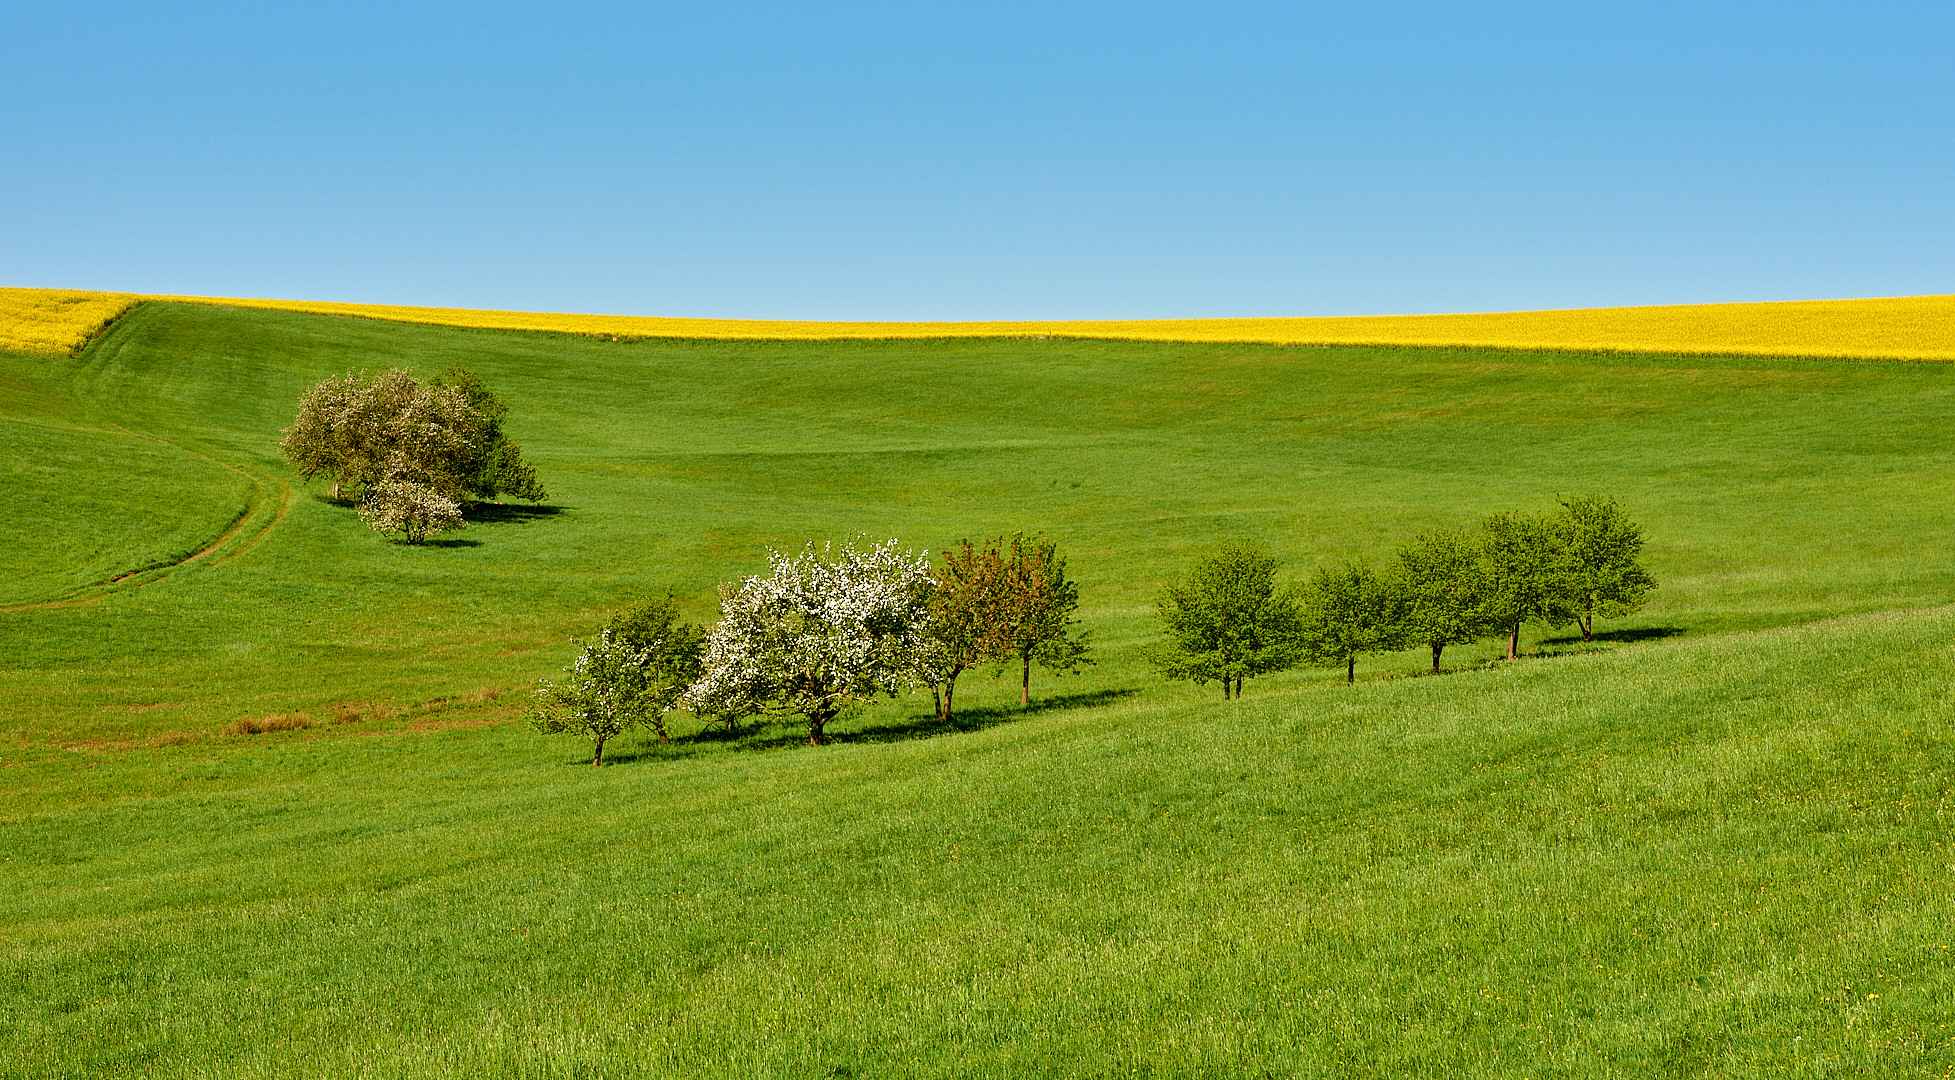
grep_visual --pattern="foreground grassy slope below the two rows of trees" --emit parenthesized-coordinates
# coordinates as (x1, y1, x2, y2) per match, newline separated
(11, 610, 1955, 1078)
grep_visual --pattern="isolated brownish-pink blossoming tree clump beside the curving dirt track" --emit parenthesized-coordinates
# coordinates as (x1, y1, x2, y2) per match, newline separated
(280, 368, 547, 544)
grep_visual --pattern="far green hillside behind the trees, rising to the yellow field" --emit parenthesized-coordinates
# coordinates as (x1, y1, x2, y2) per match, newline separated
(11, 305, 1955, 745)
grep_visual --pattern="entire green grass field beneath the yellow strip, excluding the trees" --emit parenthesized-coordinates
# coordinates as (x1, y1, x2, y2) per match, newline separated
(0, 303, 1955, 1076)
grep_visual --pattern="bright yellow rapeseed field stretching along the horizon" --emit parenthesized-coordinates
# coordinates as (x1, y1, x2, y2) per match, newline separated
(0, 290, 1955, 360)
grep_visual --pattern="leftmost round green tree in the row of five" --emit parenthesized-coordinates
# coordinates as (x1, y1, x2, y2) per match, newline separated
(1146, 544, 1302, 698)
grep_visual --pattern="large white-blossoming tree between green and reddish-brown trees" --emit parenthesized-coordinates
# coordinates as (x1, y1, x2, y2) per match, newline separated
(684, 540, 934, 745)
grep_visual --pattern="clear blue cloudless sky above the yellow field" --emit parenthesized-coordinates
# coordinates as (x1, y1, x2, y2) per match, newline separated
(0, 0, 1955, 319)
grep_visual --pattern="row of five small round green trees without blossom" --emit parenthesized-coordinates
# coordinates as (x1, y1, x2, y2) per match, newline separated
(1148, 495, 1656, 697)
